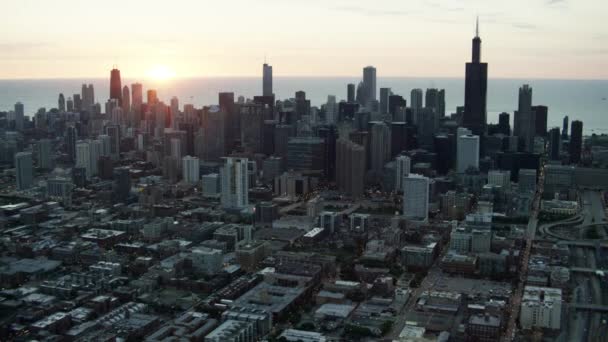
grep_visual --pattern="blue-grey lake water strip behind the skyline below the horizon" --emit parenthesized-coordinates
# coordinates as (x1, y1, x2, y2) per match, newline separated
(0, 77, 608, 134)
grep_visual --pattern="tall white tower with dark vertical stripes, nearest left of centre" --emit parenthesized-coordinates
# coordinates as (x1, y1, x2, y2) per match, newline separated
(220, 157, 249, 209)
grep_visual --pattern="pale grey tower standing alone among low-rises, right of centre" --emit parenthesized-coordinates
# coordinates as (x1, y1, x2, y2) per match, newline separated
(403, 173, 429, 221)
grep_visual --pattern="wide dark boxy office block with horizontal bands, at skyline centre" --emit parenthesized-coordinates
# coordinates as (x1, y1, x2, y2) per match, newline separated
(287, 137, 325, 171)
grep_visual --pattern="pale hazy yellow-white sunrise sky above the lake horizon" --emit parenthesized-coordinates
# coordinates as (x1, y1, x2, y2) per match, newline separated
(0, 0, 608, 79)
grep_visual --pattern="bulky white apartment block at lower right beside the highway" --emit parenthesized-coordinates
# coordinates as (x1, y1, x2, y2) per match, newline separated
(519, 286, 562, 330)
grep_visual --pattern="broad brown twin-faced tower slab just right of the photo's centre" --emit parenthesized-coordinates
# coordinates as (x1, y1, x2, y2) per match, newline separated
(336, 139, 365, 197)
